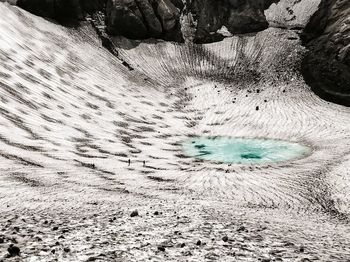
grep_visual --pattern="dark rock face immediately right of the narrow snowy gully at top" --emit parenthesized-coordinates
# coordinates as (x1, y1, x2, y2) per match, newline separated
(188, 0, 279, 43)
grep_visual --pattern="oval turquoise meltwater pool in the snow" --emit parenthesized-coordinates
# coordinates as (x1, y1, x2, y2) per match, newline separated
(182, 136, 313, 164)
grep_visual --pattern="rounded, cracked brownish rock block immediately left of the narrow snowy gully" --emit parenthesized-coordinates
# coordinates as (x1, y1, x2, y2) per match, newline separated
(106, 0, 183, 42)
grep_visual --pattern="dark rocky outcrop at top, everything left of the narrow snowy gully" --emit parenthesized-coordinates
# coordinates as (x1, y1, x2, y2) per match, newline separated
(17, 0, 184, 42)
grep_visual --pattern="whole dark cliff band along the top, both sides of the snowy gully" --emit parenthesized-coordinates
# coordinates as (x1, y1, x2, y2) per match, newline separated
(13, 0, 279, 43)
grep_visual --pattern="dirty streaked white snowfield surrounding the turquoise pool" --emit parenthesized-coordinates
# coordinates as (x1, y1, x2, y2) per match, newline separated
(0, 3, 350, 261)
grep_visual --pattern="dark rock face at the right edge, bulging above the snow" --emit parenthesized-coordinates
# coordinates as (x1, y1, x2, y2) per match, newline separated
(303, 0, 350, 106)
